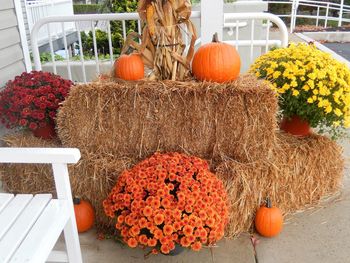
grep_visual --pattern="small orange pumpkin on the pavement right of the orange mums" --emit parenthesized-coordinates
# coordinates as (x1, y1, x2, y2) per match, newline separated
(255, 198, 283, 237)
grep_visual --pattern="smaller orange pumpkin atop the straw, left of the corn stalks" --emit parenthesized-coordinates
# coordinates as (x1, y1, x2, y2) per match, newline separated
(114, 53, 145, 80)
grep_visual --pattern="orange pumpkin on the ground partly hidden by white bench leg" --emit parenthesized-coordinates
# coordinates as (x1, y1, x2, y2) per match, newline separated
(73, 198, 95, 233)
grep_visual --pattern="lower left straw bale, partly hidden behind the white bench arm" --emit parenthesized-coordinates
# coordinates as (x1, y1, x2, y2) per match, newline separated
(0, 132, 136, 228)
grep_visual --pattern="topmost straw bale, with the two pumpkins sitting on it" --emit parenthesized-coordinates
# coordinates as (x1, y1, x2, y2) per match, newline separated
(57, 75, 277, 161)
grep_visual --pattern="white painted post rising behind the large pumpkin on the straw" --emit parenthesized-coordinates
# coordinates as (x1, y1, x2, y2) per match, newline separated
(201, 0, 224, 45)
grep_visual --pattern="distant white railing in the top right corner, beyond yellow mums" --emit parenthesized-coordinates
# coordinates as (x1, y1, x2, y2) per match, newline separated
(267, 0, 350, 32)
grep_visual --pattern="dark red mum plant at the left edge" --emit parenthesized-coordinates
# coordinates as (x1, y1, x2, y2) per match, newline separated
(0, 71, 73, 130)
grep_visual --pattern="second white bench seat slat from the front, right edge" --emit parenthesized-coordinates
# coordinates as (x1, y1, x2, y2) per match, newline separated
(0, 194, 52, 262)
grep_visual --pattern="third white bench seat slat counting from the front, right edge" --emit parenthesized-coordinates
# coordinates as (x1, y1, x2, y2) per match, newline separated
(0, 195, 33, 239)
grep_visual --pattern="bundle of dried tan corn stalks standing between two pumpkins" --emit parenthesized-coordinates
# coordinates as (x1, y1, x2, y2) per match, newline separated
(122, 0, 197, 80)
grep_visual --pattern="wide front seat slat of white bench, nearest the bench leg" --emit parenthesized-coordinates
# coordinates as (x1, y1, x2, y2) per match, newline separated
(9, 199, 69, 263)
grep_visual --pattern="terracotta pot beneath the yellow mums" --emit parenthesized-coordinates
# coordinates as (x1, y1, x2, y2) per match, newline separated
(280, 116, 311, 137)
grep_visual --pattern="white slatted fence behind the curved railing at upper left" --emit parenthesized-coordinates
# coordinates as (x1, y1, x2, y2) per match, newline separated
(25, 0, 75, 44)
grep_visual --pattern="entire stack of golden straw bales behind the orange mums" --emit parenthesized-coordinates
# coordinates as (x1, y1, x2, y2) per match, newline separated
(1, 75, 344, 237)
